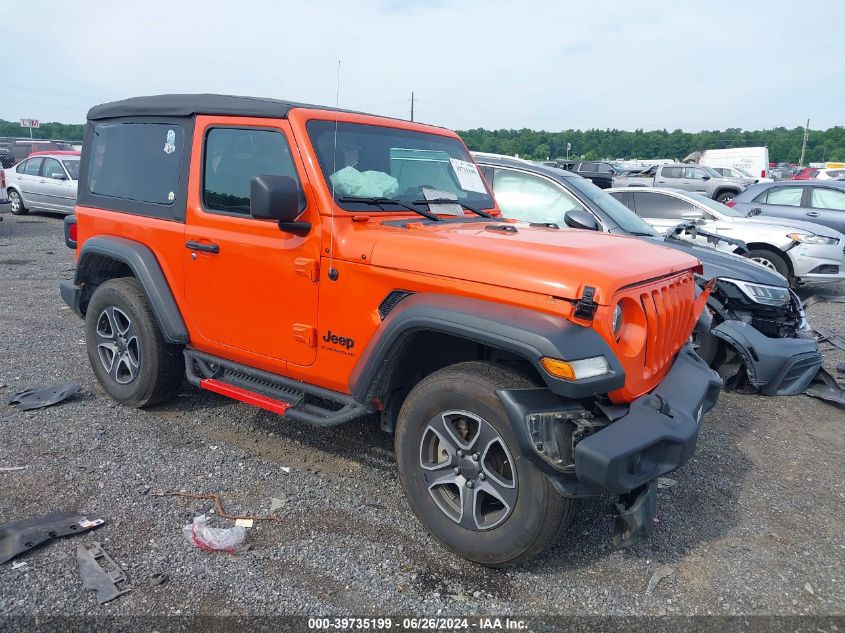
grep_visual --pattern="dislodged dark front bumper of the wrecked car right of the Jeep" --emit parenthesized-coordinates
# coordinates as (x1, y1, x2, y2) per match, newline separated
(711, 320, 822, 396)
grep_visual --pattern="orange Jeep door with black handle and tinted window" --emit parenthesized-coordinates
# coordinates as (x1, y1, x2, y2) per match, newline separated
(184, 117, 320, 372)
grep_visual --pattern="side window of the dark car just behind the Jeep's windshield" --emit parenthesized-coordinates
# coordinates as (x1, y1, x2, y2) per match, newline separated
(493, 168, 584, 226)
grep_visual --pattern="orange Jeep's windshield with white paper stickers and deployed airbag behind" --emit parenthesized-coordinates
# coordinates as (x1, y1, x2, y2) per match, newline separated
(307, 121, 495, 212)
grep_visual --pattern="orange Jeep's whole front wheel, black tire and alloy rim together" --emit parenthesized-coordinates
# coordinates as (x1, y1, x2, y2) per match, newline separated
(395, 362, 575, 567)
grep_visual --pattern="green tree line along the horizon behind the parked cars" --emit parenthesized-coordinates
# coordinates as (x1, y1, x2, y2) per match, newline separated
(0, 119, 845, 164)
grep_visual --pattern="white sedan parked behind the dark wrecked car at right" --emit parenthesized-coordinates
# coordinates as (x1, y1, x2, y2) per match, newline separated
(606, 188, 845, 286)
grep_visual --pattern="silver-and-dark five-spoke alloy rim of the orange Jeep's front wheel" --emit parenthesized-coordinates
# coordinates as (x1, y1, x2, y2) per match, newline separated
(420, 411, 519, 531)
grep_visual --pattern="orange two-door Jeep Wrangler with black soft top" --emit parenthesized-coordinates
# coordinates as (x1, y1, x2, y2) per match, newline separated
(61, 95, 720, 565)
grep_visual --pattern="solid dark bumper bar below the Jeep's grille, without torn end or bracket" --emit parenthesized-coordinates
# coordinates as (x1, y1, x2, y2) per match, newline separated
(574, 344, 722, 494)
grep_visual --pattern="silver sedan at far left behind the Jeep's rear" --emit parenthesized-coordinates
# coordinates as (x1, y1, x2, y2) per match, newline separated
(5, 153, 79, 215)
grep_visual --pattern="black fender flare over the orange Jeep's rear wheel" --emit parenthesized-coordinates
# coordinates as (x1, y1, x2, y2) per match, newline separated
(74, 236, 189, 344)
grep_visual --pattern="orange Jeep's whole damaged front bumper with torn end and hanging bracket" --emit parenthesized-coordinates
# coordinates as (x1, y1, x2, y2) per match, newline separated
(497, 344, 722, 541)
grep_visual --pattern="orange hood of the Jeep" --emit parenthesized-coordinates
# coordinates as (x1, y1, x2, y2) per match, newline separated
(370, 222, 698, 304)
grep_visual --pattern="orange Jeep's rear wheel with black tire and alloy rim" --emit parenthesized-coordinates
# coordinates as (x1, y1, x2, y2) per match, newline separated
(85, 277, 185, 408)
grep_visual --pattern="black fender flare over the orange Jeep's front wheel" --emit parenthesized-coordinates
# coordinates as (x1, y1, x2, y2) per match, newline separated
(349, 293, 625, 401)
